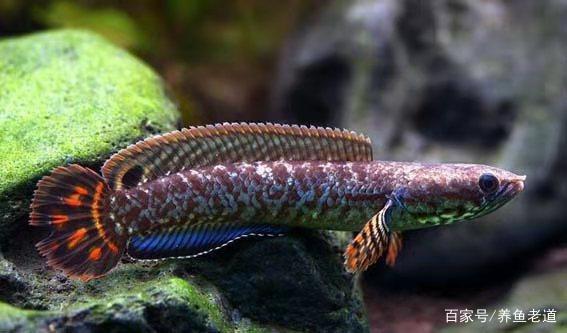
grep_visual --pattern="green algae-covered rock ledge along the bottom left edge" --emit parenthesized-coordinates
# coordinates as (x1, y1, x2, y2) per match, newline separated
(0, 277, 300, 333)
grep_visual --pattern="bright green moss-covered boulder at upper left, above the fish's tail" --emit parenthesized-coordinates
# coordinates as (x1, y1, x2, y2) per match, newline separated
(0, 30, 179, 238)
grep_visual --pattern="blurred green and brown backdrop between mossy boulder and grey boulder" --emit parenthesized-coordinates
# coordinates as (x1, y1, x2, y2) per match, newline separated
(0, 0, 321, 124)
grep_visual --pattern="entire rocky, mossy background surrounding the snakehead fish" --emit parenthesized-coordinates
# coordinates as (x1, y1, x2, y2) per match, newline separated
(0, 0, 567, 333)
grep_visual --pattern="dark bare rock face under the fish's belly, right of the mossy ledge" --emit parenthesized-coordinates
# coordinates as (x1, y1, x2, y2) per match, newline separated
(191, 232, 368, 332)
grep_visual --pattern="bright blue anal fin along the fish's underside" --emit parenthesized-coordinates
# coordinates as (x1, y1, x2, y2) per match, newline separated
(127, 223, 288, 260)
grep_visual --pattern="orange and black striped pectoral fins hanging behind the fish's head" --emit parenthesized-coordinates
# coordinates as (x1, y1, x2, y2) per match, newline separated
(344, 200, 402, 273)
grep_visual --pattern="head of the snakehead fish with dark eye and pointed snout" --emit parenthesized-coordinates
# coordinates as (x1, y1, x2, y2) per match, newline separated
(398, 164, 526, 229)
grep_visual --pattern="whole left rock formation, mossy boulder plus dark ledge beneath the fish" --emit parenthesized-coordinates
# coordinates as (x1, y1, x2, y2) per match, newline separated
(0, 31, 368, 332)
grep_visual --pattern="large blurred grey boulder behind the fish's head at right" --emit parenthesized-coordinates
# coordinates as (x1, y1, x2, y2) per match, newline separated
(273, 0, 567, 287)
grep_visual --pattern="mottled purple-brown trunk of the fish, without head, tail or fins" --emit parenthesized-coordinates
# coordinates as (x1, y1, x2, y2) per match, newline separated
(111, 161, 394, 234)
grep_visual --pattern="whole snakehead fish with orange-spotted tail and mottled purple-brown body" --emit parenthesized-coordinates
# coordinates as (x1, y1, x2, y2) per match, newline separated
(30, 123, 525, 281)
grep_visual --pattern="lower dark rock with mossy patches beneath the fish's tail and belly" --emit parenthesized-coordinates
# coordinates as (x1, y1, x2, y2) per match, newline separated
(0, 232, 368, 332)
